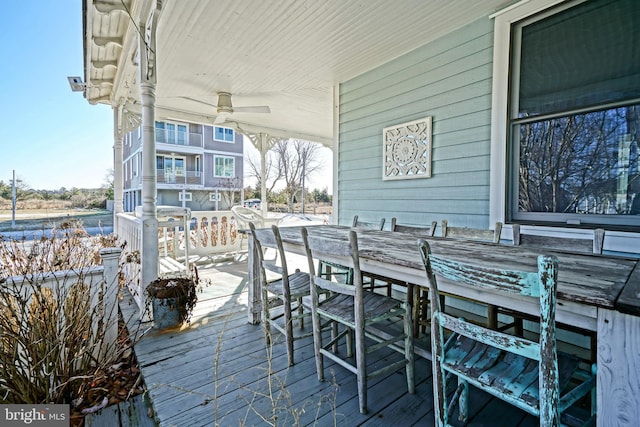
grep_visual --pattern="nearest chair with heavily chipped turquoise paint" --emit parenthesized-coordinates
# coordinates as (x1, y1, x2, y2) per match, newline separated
(418, 239, 596, 426)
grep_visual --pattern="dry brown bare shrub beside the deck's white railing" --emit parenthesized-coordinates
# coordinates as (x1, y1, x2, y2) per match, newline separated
(0, 221, 126, 404)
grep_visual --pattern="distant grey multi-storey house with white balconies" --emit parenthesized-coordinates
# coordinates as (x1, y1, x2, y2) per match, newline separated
(122, 120, 244, 212)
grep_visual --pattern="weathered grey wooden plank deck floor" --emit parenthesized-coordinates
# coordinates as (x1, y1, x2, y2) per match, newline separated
(121, 263, 538, 427)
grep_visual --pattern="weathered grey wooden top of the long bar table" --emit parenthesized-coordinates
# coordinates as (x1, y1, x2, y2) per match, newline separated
(280, 225, 640, 314)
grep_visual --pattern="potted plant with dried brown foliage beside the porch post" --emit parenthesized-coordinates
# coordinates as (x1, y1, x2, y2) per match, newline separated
(146, 266, 200, 329)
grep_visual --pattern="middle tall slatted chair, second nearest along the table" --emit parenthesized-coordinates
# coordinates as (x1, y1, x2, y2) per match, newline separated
(301, 227, 415, 414)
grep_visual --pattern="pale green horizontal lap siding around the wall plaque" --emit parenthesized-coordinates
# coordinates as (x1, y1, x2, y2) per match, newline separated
(338, 18, 493, 228)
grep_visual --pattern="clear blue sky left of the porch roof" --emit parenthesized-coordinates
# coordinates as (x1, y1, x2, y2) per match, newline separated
(0, 0, 113, 190)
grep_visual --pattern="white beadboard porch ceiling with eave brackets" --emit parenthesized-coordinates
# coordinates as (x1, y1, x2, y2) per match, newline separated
(83, 0, 513, 145)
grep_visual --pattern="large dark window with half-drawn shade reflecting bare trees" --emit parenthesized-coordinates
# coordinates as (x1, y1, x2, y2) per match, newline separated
(492, 0, 640, 231)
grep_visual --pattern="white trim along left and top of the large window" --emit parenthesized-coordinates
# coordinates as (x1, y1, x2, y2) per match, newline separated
(489, 0, 586, 224)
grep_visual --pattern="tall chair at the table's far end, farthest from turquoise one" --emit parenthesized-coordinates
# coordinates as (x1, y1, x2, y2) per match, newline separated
(249, 222, 312, 366)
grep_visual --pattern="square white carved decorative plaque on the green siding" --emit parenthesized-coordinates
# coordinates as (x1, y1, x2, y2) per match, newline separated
(382, 117, 431, 181)
